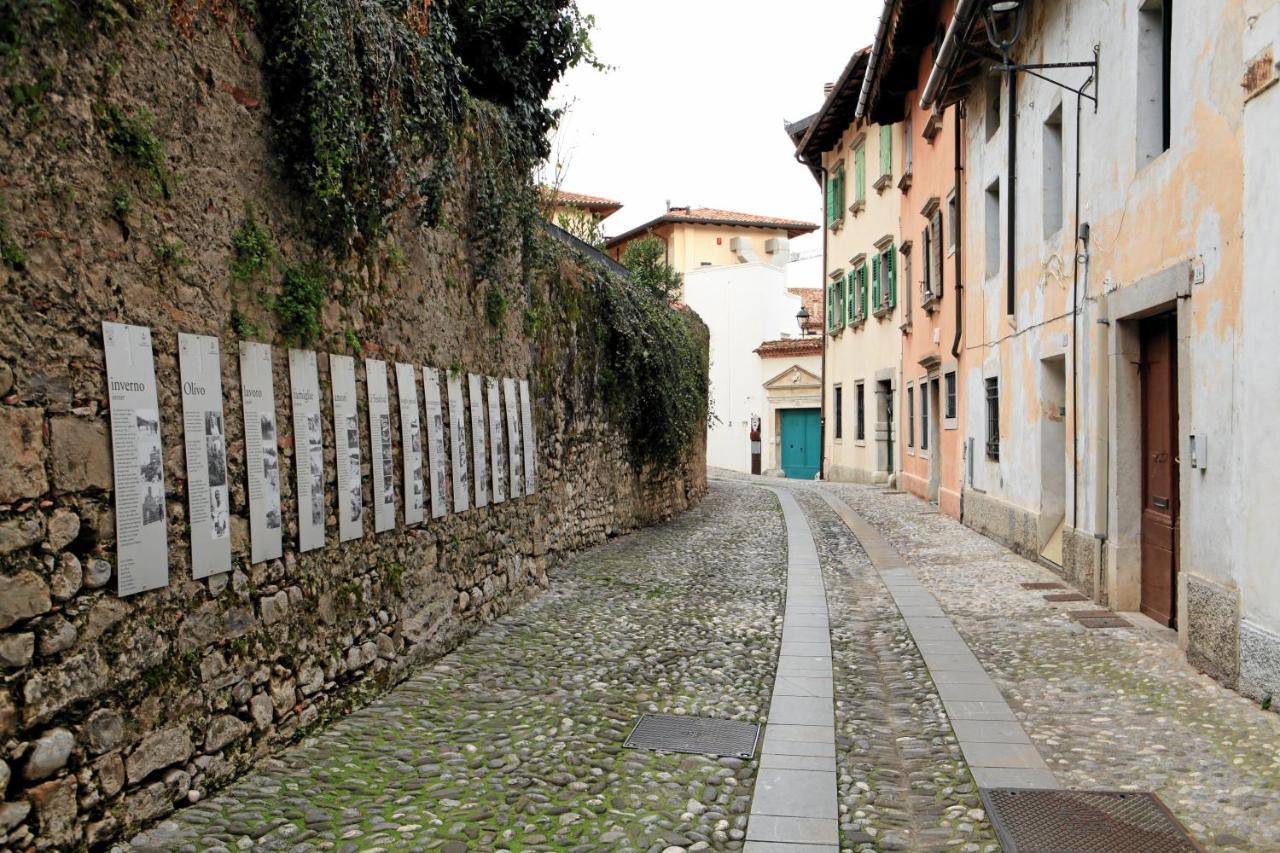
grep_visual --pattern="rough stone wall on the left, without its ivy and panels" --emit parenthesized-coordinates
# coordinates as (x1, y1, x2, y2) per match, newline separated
(0, 4, 707, 849)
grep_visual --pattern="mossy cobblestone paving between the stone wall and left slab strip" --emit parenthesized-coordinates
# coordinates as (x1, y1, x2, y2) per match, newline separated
(124, 483, 786, 853)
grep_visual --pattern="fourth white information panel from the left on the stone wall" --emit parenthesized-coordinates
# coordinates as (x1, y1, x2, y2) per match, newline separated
(289, 350, 325, 551)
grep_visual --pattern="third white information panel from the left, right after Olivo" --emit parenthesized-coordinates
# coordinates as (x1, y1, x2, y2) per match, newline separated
(241, 341, 282, 562)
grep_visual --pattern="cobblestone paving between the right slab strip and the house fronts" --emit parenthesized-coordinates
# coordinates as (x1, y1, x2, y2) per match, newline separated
(820, 484, 1280, 850)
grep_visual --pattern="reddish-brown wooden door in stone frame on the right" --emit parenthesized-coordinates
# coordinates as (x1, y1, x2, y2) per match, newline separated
(1140, 314, 1178, 628)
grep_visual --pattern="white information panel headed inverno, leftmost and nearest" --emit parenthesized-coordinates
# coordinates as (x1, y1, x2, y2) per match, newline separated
(102, 323, 169, 596)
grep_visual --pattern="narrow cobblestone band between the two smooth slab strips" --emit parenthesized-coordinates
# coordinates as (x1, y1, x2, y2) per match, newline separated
(794, 487, 1000, 853)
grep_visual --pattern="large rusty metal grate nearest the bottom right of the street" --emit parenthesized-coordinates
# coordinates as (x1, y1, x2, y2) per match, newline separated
(980, 788, 1204, 853)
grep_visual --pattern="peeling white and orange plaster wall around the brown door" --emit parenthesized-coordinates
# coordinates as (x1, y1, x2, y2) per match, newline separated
(964, 0, 1249, 676)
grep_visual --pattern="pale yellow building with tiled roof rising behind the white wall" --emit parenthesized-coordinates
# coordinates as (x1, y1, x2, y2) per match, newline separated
(605, 207, 818, 273)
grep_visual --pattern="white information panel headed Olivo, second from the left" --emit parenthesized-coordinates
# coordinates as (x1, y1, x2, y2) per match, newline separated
(178, 333, 232, 579)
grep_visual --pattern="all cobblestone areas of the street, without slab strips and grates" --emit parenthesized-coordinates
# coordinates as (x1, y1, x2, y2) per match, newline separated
(133, 473, 1280, 853)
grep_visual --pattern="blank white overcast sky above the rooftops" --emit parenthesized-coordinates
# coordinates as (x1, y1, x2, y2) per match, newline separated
(540, 0, 883, 258)
